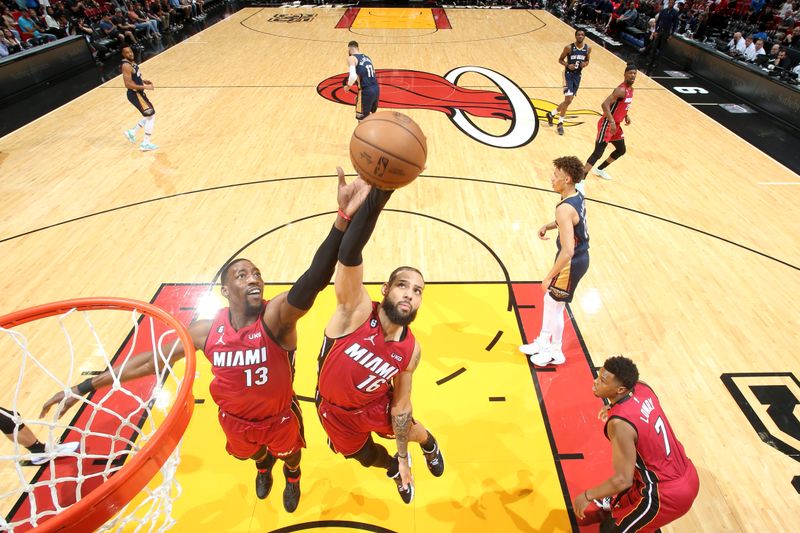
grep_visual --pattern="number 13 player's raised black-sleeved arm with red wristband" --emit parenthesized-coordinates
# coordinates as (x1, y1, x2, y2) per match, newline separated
(264, 167, 370, 349)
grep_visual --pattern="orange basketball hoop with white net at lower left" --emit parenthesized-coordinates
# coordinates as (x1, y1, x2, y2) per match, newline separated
(0, 298, 195, 532)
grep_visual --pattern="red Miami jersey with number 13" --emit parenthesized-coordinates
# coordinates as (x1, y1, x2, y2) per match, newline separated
(203, 301, 294, 421)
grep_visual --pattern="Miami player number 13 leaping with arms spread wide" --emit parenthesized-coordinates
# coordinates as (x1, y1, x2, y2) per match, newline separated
(42, 168, 369, 513)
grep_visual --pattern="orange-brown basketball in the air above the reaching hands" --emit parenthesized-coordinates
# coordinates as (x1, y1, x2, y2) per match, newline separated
(350, 111, 428, 190)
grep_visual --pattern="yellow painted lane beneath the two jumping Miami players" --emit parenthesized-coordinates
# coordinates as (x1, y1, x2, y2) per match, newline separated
(174, 284, 570, 532)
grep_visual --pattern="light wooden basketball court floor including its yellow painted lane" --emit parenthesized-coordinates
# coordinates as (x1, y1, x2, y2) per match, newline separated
(0, 8, 800, 532)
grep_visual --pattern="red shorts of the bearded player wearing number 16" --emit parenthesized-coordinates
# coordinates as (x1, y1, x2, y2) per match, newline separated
(317, 397, 394, 456)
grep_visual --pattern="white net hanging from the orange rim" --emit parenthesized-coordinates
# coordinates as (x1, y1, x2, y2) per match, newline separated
(0, 309, 193, 532)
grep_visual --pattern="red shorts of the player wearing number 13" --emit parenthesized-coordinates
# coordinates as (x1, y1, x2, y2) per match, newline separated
(218, 400, 306, 459)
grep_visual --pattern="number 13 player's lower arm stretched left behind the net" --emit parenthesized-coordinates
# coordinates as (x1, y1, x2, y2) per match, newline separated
(39, 320, 211, 418)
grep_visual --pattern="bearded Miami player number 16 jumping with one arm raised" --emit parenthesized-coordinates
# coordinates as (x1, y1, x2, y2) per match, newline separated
(316, 189, 444, 503)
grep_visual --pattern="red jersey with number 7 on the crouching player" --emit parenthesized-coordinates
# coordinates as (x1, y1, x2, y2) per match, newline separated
(605, 381, 691, 483)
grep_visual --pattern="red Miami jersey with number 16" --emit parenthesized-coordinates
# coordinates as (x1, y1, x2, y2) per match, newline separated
(317, 302, 416, 409)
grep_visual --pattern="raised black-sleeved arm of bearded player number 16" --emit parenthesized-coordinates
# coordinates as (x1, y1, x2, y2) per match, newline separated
(325, 188, 393, 338)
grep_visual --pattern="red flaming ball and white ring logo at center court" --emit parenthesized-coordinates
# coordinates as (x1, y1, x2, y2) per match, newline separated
(317, 66, 600, 148)
